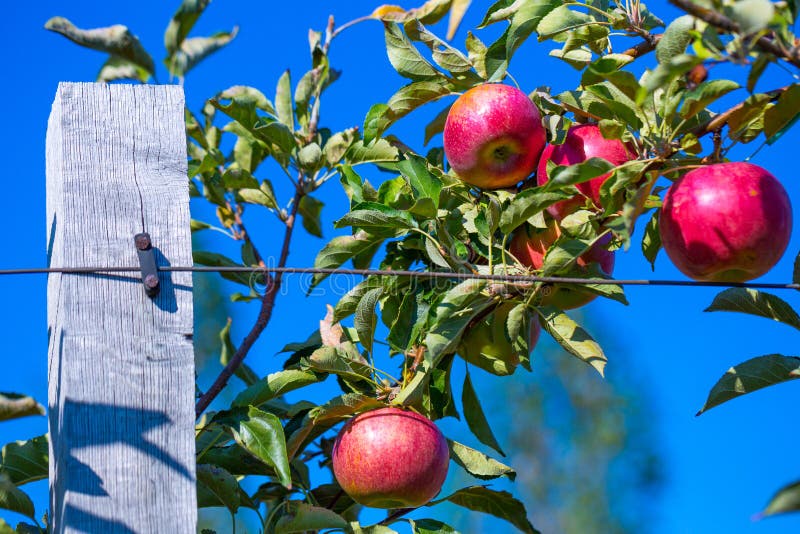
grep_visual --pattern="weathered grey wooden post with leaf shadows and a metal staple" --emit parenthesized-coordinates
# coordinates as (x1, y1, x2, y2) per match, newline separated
(47, 83, 197, 533)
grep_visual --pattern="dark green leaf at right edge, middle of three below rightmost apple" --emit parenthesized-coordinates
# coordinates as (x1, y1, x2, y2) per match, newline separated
(697, 354, 800, 415)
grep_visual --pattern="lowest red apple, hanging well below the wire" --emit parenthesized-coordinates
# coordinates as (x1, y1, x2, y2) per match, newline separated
(333, 407, 450, 508)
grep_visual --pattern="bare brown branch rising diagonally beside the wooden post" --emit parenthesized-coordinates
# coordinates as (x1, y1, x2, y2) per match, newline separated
(195, 188, 305, 417)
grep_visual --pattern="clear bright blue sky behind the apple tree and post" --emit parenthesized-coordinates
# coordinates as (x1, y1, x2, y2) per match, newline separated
(0, 0, 800, 534)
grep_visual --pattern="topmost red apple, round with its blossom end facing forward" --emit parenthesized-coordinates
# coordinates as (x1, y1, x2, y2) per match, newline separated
(444, 83, 546, 189)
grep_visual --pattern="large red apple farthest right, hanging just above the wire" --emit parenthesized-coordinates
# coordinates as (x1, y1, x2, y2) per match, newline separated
(659, 163, 792, 282)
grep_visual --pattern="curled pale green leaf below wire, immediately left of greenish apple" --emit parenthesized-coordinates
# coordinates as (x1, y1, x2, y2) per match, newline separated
(425, 280, 491, 365)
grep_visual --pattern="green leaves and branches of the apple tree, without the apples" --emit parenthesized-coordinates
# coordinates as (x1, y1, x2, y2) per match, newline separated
(26, 0, 800, 532)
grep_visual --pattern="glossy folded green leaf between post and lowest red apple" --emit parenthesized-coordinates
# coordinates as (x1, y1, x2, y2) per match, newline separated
(231, 406, 292, 489)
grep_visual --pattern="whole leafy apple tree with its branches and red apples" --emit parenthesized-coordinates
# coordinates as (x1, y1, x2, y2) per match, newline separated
(4, 0, 800, 532)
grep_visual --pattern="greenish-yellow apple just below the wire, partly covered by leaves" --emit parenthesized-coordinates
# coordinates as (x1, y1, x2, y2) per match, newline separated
(458, 303, 542, 376)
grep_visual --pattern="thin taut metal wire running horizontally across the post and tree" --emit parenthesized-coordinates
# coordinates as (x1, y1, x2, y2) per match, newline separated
(0, 265, 800, 290)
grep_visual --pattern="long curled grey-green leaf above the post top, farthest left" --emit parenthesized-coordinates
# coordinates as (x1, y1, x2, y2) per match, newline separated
(44, 17, 155, 74)
